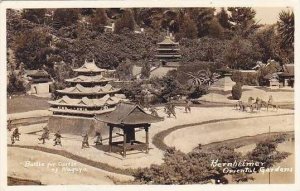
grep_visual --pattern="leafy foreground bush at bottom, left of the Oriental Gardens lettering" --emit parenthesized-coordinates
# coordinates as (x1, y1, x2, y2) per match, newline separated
(134, 147, 247, 184)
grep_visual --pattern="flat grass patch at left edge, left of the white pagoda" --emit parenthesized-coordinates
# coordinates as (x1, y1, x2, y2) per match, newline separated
(7, 95, 50, 114)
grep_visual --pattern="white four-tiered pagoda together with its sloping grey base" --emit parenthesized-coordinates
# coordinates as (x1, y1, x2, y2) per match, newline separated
(48, 60, 126, 134)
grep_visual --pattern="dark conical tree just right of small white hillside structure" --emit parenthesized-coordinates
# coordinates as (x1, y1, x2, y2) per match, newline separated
(115, 10, 135, 34)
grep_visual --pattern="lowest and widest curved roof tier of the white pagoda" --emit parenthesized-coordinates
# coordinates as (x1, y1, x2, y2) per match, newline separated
(48, 95, 127, 107)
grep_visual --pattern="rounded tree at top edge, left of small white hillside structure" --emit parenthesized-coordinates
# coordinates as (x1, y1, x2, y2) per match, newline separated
(90, 9, 107, 32)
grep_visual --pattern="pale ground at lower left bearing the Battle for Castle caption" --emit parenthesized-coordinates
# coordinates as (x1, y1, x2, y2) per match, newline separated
(8, 147, 131, 185)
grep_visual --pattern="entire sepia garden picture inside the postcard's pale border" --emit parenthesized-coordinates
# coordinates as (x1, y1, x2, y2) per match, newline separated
(1, 0, 296, 187)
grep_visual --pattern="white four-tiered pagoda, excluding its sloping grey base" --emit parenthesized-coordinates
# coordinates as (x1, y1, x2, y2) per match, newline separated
(49, 61, 125, 117)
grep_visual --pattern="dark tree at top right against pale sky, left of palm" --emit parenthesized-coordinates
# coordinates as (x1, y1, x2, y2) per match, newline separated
(227, 7, 260, 37)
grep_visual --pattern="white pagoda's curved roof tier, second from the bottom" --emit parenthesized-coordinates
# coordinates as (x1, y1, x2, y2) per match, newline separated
(57, 84, 120, 95)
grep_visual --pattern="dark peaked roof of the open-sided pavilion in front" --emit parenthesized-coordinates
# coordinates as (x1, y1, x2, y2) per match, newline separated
(96, 102, 163, 125)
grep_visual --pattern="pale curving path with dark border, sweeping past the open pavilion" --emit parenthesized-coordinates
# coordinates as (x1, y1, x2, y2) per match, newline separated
(8, 107, 294, 183)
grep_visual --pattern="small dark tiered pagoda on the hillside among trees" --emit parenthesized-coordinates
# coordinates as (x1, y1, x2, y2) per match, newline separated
(155, 36, 181, 63)
